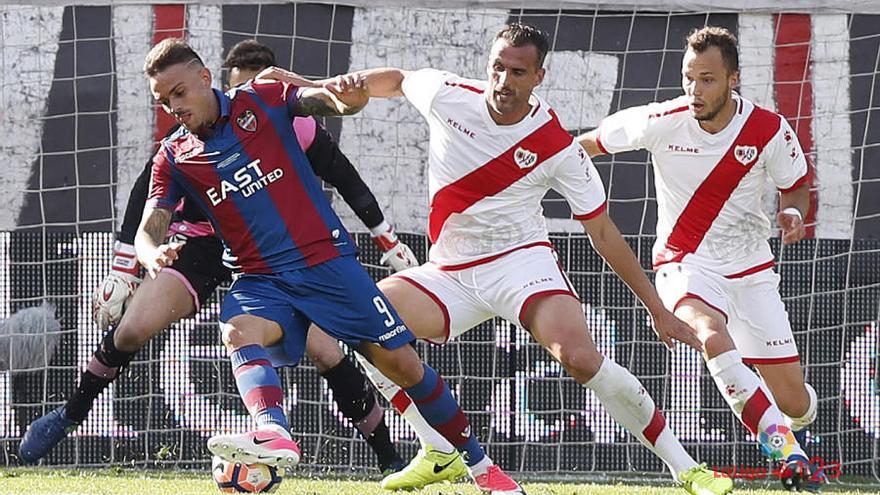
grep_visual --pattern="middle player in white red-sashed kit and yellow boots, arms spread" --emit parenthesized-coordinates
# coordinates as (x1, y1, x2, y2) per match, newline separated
(320, 24, 732, 493)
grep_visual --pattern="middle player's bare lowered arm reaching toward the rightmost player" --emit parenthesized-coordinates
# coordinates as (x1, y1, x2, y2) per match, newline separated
(581, 212, 703, 351)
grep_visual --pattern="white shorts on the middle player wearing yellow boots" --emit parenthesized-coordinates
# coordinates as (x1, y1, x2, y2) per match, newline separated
(391, 242, 578, 344)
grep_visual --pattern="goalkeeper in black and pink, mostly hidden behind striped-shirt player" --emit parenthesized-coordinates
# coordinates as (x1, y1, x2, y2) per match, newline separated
(21, 41, 418, 472)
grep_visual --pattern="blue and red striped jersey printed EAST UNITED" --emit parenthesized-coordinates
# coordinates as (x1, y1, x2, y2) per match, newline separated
(149, 82, 356, 273)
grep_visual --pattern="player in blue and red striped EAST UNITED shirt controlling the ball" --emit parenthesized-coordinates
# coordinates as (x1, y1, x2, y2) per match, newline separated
(138, 39, 522, 495)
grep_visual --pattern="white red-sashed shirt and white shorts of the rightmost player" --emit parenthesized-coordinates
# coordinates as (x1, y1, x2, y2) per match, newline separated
(596, 94, 809, 364)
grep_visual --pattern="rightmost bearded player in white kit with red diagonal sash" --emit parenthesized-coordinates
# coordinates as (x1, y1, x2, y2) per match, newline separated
(578, 27, 819, 489)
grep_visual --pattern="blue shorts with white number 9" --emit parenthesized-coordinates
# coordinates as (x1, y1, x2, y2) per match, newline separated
(220, 255, 415, 367)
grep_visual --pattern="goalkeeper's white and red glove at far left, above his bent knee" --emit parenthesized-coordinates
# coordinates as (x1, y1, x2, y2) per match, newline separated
(92, 241, 141, 331)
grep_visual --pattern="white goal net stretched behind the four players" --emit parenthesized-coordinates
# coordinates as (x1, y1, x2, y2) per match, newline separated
(0, 0, 880, 477)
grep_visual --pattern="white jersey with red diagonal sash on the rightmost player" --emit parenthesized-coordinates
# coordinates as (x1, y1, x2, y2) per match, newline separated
(598, 95, 809, 277)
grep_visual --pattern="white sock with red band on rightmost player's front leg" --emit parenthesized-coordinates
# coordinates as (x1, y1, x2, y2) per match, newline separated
(706, 350, 804, 455)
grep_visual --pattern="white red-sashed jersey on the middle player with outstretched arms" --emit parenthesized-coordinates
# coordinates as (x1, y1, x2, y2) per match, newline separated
(403, 69, 605, 266)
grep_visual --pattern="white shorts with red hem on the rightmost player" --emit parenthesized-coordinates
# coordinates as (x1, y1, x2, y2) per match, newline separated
(656, 263, 800, 364)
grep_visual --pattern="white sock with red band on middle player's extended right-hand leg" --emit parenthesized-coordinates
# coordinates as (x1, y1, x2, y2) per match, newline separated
(584, 357, 697, 480)
